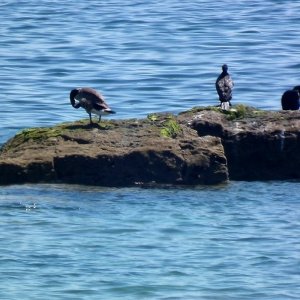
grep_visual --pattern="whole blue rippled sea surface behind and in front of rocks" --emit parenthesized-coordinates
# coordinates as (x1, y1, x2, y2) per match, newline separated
(0, 0, 300, 300)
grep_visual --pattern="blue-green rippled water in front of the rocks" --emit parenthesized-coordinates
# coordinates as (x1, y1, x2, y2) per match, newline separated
(0, 182, 300, 299)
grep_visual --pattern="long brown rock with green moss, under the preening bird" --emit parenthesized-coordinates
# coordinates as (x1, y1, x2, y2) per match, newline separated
(0, 114, 228, 186)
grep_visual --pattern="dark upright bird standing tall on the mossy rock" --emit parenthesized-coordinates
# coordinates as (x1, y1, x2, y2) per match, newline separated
(216, 65, 234, 110)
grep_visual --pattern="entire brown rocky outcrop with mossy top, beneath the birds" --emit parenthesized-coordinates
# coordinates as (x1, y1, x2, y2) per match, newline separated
(0, 105, 300, 186)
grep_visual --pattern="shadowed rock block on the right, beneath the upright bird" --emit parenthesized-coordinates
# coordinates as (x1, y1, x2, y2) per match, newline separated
(183, 107, 300, 180)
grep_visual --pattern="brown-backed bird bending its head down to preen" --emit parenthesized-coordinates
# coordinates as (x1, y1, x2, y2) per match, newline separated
(70, 87, 115, 124)
